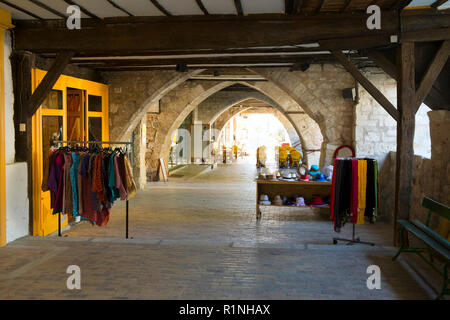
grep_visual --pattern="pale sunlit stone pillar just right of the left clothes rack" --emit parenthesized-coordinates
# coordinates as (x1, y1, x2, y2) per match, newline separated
(133, 116, 147, 190)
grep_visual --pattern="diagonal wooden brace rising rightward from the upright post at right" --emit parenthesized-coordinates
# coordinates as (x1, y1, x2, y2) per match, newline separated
(414, 40, 450, 113)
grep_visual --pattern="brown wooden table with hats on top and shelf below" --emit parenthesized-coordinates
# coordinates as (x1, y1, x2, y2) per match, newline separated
(256, 180, 331, 220)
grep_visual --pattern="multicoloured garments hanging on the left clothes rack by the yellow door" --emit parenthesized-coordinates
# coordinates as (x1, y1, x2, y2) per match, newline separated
(42, 147, 136, 226)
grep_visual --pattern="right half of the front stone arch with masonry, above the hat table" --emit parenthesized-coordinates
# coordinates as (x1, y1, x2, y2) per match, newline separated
(248, 64, 355, 165)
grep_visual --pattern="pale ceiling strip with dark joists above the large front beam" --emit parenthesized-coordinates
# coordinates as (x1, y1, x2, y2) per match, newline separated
(0, 0, 449, 20)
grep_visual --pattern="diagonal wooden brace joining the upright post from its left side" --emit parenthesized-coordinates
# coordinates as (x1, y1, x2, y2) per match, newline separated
(331, 50, 399, 120)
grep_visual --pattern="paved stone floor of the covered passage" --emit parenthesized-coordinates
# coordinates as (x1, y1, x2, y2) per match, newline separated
(0, 164, 439, 299)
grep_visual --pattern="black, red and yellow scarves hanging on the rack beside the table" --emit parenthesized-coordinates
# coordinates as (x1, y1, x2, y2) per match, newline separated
(330, 158, 379, 232)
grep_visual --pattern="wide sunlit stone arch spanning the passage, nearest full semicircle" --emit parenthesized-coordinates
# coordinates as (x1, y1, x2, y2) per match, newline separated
(146, 74, 322, 178)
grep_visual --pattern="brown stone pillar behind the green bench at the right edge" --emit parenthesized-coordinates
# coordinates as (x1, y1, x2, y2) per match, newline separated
(428, 110, 450, 239)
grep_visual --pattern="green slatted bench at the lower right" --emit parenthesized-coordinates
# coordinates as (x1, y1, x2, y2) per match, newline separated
(393, 197, 450, 299)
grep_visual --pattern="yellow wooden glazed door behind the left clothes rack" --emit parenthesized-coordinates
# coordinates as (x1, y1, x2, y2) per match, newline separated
(32, 69, 109, 236)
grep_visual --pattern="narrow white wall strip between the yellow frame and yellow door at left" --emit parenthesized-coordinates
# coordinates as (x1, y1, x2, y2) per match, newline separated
(4, 31, 29, 243)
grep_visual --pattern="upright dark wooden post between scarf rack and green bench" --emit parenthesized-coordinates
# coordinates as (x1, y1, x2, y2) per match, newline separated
(394, 42, 416, 245)
